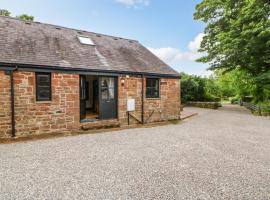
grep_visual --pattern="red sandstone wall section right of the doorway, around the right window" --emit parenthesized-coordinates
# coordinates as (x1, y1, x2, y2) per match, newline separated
(118, 76, 181, 124)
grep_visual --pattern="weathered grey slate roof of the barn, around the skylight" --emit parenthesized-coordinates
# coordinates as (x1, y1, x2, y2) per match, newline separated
(0, 17, 179, 76)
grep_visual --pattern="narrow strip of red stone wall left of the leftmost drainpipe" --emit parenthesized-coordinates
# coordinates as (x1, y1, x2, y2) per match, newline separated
(0, 71, 11, 137)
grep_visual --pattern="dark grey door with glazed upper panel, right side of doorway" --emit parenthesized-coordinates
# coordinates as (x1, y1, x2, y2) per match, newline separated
(99, 77, 117, 119)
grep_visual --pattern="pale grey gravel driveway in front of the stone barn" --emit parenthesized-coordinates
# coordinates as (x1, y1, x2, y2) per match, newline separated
(0, 106, 270, 200)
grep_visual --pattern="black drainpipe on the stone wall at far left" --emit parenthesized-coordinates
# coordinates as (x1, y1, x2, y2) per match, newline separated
(9, 66, 18, 138)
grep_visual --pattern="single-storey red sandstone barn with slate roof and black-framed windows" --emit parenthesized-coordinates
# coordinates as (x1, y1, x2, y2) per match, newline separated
(0, 17, 180, 137)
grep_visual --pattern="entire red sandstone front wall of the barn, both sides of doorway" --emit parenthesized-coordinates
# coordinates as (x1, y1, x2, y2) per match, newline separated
(0, 71, 180, 137)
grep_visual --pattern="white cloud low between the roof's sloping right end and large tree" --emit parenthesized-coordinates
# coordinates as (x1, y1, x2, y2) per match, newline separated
(148, 33, 209, 75)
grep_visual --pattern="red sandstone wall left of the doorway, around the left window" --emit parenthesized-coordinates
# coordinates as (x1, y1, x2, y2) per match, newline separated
(0, 71, 80, 136)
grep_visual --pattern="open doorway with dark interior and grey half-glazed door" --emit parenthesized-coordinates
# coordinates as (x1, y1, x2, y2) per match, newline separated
(80, 75, 117, 121)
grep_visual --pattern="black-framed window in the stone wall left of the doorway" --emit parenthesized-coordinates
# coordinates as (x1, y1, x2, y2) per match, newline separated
(36, 73, 52, 101)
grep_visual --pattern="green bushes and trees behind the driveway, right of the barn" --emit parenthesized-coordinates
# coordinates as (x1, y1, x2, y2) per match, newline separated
(181, 69, 270, 105)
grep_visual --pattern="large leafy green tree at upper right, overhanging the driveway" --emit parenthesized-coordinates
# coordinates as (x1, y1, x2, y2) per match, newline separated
(194, 0, 270, 101)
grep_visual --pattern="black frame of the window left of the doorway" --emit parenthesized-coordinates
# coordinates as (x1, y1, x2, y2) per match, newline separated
(36, 72, 52, 102)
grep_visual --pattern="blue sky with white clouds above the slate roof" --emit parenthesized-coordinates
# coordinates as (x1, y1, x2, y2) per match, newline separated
(0, 0, 209, 75)
